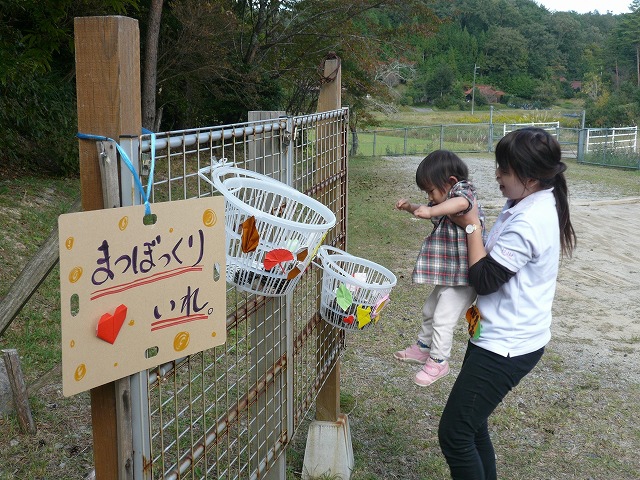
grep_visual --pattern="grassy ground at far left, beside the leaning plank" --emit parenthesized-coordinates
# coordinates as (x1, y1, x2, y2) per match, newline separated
(0, 177, 93, 479)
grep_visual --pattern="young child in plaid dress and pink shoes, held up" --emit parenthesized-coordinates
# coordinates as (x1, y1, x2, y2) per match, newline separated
(393, 150, 484, 386)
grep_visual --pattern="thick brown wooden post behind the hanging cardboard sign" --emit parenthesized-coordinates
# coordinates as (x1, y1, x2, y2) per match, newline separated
(74, 16, 142, 480)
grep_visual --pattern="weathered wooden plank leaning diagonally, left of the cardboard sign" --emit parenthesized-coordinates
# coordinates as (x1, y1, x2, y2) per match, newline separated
(0, 199, 80, 336)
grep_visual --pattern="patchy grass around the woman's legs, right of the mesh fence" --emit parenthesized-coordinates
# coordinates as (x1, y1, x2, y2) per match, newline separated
(289, 151, 640, 480)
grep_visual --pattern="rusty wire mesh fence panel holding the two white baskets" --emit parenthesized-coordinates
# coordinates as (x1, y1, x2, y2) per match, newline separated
(133, 109, 348, 479)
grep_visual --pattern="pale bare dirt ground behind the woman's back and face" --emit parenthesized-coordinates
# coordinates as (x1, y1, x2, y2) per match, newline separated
(465, 158, 640, 375)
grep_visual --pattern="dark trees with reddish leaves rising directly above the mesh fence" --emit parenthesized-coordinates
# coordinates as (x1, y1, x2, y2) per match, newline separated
(152, 0, 438, 128)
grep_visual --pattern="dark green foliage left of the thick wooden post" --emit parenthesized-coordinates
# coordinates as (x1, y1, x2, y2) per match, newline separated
(0, 0, 138, 174)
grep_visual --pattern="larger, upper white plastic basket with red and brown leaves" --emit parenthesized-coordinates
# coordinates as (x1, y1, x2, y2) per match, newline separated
(198, 163, 336, 297)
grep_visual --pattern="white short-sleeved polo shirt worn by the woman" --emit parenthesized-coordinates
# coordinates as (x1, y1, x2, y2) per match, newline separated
(471, 189, 560, 357)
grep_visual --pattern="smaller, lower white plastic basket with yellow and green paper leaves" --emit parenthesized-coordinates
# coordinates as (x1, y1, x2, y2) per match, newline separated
(317, 245, 397, 331)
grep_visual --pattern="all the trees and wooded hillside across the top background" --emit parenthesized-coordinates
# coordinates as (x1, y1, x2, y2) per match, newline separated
(0, 0, 640, 173)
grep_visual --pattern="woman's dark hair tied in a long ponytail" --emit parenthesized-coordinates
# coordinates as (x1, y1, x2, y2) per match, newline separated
(496, 127, 576, 256)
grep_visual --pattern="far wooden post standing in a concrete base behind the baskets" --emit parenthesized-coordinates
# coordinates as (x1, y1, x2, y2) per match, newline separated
(315, 56, 345, 422)
